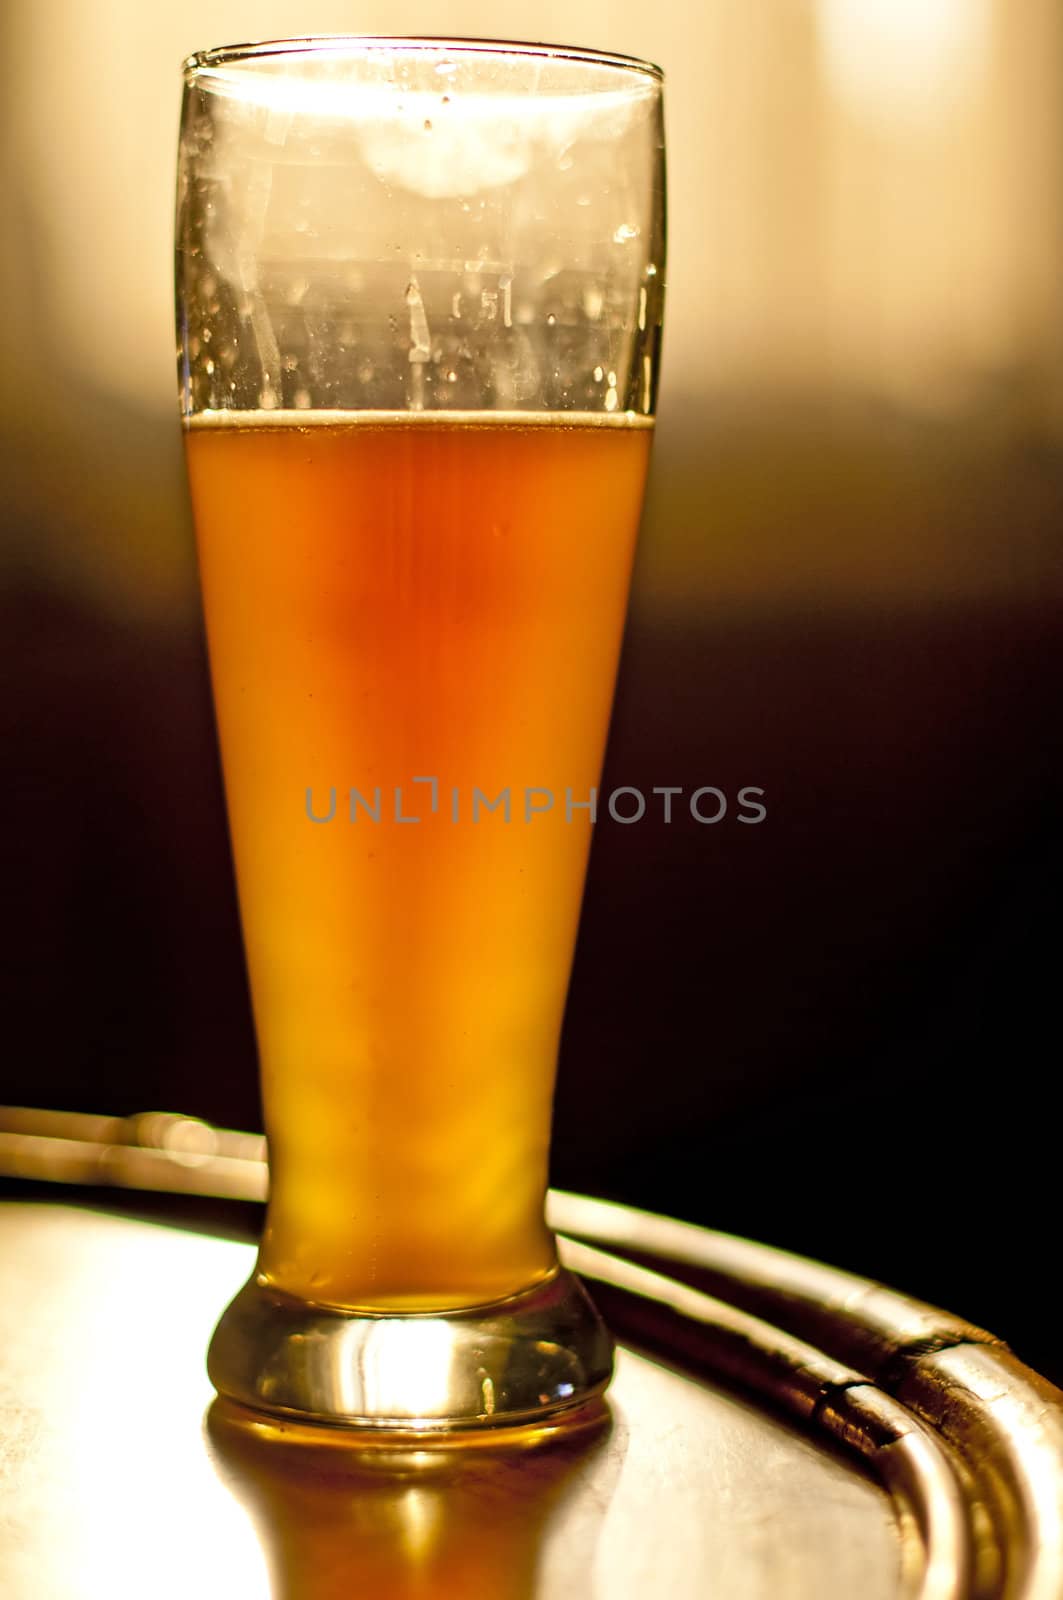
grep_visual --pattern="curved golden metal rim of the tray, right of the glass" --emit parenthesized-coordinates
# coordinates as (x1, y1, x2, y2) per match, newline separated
(548, 1190, 1063, 1600)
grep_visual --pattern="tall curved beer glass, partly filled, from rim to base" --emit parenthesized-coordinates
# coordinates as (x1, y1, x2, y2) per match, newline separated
(178, 38, 664, 1430)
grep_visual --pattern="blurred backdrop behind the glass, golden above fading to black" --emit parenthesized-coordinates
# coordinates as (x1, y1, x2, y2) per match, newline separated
(0, 0, 1063, 1378)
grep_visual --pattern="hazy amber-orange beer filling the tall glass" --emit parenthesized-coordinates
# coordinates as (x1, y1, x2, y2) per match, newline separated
(186, 411, 652, 1310)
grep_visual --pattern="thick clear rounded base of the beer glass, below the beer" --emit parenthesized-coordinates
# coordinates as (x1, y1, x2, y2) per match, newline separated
(207, 1267, 613, 1434)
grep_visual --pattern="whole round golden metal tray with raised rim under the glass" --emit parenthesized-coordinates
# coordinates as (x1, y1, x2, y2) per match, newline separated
(0, 1114, 1063, 1600)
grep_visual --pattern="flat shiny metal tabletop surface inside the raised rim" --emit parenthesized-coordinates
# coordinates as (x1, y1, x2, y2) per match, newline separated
(0, 1203, 913, 1600)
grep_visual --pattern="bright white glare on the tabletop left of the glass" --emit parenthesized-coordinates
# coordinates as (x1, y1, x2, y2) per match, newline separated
(0, 1206, 269, 1600)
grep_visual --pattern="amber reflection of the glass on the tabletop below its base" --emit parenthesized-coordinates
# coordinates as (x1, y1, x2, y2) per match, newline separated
(208, 1400, 615, 1600)
